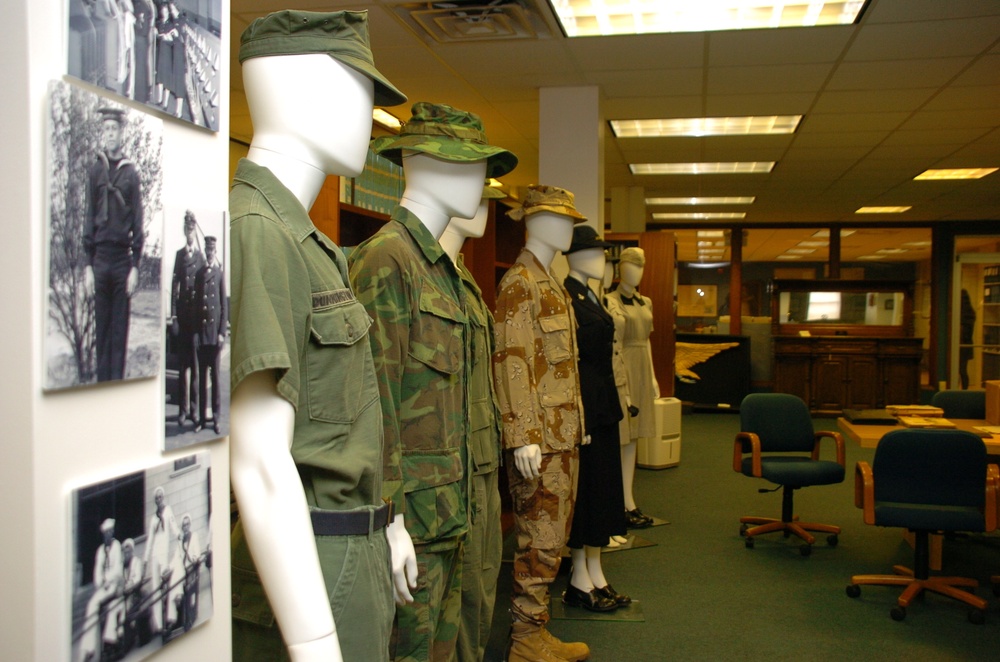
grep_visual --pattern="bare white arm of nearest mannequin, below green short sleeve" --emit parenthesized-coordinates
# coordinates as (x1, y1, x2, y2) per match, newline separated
(230, 372, 342, 662)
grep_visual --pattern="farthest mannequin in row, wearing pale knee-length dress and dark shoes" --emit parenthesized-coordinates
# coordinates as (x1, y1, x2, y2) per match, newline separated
(609, 247, 660, 528)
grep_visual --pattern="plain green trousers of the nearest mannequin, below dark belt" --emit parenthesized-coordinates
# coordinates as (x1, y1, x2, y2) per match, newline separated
(232, 523, 395, 662)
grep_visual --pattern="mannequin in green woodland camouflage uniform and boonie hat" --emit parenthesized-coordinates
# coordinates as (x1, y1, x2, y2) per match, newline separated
(351, 102, 517, 661)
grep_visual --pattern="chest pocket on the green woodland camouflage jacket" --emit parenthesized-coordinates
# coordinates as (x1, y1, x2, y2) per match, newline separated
(409, 283, 466, 375)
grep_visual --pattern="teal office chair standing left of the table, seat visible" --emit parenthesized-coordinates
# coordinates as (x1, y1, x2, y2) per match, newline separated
(733, 393, 844, 556)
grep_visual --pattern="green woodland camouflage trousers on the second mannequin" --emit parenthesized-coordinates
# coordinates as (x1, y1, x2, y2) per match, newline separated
(392, 542, 463, 662)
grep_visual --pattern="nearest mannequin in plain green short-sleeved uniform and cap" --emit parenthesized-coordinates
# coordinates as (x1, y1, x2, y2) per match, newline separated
(230, 12, 405, 661)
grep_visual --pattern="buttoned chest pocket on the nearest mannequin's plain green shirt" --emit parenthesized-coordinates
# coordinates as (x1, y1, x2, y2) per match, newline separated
(305, 295, 378, 423)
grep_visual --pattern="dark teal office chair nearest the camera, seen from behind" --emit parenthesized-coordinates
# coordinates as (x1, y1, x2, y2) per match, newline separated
(847, 429, 1000, 623)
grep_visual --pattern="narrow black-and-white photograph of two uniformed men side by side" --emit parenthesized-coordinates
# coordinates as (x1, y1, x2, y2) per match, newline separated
(161, 205, 229, 451)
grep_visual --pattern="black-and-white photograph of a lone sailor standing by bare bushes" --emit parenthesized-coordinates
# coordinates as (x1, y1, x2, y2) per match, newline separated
(45, 81, 163, 390)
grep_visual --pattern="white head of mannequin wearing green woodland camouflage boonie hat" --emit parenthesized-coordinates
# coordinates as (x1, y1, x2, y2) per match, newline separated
(399, 149, 486, 239)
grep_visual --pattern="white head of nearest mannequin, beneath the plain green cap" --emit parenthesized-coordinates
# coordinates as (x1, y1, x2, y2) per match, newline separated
(243, 53, 375, 177)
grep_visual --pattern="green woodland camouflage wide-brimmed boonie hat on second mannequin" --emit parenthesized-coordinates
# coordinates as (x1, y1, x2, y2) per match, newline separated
(372, 101, 517, 177)
